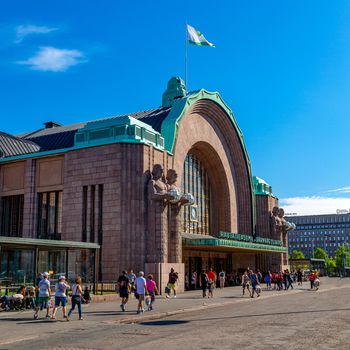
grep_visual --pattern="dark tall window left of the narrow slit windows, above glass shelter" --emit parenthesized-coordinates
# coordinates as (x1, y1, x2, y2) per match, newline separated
(38, 191, 62, 239)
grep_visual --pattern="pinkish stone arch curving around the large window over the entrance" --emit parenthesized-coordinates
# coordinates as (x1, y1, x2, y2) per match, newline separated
(173, 98, 254, 234)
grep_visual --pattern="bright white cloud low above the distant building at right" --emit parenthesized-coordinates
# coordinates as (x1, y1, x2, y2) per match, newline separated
(280, 196, 350, 215)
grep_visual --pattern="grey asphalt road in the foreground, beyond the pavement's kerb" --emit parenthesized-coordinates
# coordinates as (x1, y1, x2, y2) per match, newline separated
(0, 280, 350, 350)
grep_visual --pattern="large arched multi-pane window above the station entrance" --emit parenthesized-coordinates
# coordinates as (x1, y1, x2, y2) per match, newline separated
(182, 154, 211, 235)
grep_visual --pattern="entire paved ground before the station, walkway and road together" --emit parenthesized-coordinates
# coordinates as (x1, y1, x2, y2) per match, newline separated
(0, 278, 350, 350)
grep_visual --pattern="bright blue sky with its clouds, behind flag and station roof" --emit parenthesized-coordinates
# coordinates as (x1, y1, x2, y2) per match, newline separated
(0, 0, 350, 214)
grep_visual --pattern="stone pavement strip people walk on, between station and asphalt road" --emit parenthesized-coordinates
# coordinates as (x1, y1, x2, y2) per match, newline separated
(0, 278, 350, 349)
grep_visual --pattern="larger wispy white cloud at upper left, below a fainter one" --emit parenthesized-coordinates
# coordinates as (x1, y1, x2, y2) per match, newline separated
(17, 47, 86, 72)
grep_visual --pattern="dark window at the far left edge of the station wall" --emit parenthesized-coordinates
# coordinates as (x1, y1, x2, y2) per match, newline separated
(1, 194, 24, 237)
